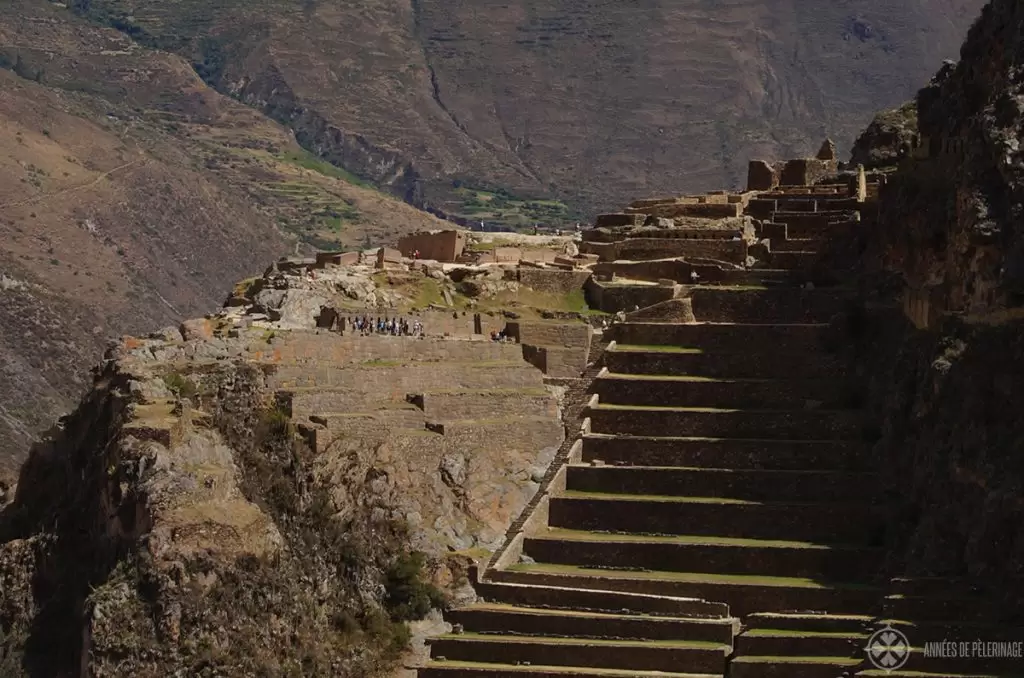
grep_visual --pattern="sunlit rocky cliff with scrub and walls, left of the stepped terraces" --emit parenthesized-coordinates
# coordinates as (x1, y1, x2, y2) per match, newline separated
(0, 259, 563, 677)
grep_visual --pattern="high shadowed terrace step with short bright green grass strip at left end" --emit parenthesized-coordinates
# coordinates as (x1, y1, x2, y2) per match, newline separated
(604, 344, 848, 379)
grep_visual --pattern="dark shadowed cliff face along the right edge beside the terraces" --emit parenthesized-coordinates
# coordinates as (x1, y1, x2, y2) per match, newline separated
(855, 0, 1024, 622)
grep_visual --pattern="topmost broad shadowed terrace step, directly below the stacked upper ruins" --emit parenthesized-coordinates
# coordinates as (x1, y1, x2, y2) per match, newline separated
(689, 287, 851, 324)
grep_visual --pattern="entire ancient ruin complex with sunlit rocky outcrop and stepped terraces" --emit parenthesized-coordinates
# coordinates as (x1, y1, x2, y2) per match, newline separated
(0, 130, 1021, 678)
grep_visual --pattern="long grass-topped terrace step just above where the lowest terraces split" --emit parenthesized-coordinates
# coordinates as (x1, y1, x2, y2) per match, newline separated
(487, 563, 880, 616)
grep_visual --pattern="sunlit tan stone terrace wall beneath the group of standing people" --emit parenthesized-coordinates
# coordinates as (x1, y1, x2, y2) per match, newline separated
(258, 331, 564, 552)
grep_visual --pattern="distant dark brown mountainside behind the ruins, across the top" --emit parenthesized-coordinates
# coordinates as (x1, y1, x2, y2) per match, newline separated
(77, 0, 982, 222)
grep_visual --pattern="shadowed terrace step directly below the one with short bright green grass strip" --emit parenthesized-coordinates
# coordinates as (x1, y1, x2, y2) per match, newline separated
(593, 373, 860, 410)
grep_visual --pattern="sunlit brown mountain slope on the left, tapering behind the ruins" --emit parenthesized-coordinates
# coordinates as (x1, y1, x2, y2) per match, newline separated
(0, 0, 448, 474)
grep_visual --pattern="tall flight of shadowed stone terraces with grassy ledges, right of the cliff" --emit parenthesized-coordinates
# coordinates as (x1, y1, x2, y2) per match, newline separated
(420, 153, 1007, 678)
